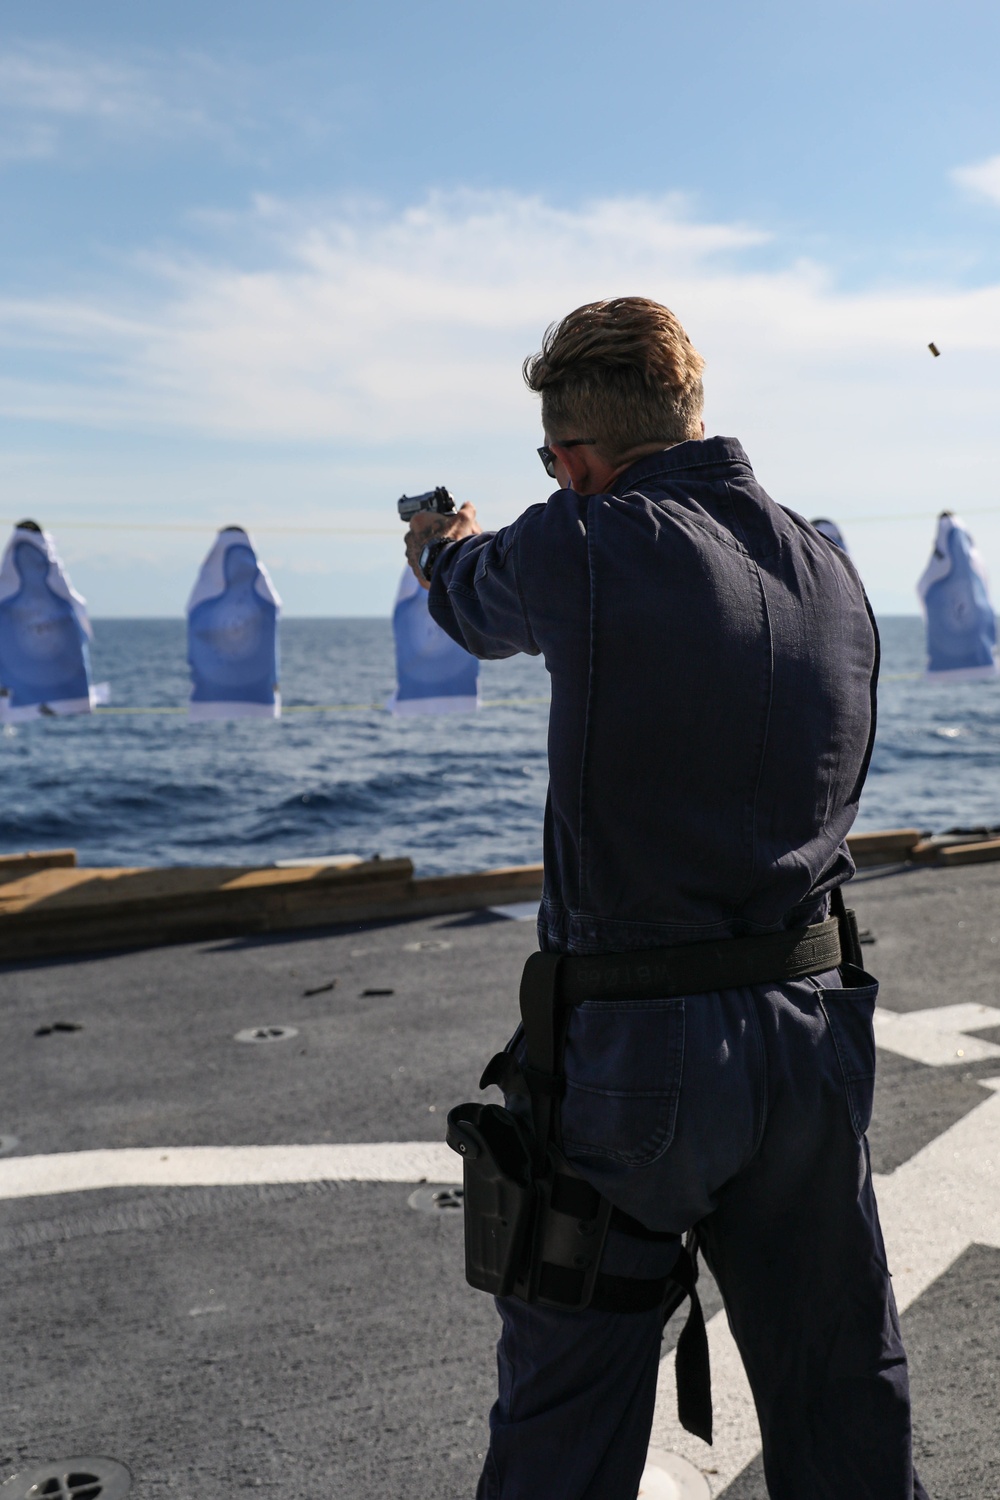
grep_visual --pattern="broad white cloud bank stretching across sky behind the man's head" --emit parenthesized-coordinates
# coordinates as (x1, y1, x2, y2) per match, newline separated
(0, 194, 1000, 443)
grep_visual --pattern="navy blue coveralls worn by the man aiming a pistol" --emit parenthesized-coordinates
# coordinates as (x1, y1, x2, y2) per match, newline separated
(430, 438, 925, 1500)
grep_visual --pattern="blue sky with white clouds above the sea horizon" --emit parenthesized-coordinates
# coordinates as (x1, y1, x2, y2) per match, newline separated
(0, 0, 1000, 617)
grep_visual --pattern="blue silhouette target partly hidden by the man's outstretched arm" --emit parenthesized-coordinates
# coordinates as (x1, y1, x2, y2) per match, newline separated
(385, 569, 480, 714)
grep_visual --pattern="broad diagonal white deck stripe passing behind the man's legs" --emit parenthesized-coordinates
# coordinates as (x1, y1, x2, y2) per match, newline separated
(652, 1079, 1000, 1496)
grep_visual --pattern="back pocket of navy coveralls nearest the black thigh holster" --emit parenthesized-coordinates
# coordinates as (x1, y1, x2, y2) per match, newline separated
(562, 999, 684, 1167)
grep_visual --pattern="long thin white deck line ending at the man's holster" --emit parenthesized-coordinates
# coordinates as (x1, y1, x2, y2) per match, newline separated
(0, 1140, 462, 1199)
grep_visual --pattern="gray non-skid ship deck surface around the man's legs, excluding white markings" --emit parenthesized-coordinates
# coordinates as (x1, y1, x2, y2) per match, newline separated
(0, 866, 1000, 1500)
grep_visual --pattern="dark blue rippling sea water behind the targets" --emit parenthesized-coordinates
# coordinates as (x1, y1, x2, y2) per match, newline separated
(0, 618, 1000, 873)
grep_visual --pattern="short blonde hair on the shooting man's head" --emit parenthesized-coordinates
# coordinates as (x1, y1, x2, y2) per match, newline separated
(523, 297, 705, 462)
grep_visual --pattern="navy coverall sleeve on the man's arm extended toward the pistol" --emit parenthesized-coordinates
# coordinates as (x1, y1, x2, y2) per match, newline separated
(427, 506, 544, 659)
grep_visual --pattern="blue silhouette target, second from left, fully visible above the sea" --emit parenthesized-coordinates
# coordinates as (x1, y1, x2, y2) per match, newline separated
(187, 527, 282, 719)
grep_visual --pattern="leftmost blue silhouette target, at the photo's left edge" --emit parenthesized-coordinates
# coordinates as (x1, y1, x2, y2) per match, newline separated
(0, 522, 93, 722)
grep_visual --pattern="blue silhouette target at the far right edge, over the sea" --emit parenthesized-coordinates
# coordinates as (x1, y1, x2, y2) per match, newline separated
(916, 510, 997, 683)
